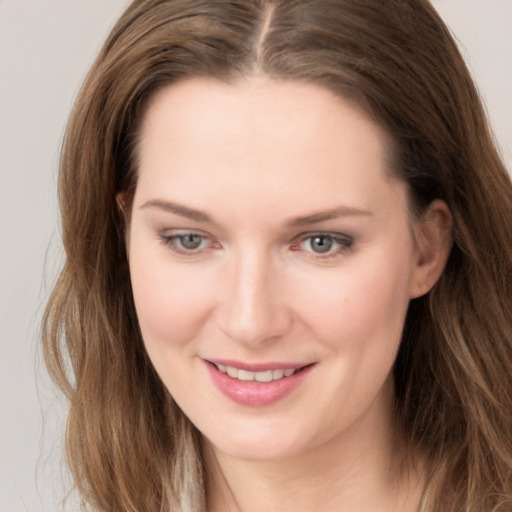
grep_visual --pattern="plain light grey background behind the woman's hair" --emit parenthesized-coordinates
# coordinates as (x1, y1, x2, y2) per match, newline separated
(0, 0, 512, 512)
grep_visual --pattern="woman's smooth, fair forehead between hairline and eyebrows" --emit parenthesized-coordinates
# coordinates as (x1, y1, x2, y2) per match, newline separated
(137, 78, 402, 217)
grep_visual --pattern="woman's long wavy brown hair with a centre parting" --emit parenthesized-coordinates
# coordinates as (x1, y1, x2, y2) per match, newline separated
(43, 0, 512, 512)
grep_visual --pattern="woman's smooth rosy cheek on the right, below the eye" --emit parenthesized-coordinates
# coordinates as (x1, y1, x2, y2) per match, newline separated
(301, 248, 410, 352)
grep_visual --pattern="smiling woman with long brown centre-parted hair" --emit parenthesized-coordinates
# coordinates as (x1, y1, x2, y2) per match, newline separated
(44, 0, 512, 512)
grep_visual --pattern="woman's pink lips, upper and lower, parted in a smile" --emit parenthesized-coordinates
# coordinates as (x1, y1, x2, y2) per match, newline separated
(205, 359, 314, 407)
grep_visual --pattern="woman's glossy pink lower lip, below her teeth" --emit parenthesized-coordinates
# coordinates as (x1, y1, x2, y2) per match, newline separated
(206, 362, 314, 407)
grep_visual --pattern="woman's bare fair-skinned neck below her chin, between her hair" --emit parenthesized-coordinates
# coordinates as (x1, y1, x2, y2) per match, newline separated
(204, 380, 422, 512)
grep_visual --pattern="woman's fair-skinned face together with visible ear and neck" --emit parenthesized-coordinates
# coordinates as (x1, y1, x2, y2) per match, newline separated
(128, 77, 450, 512)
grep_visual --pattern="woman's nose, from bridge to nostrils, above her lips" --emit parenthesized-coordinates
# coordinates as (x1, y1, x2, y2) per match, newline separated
(218, 249, 292, 347)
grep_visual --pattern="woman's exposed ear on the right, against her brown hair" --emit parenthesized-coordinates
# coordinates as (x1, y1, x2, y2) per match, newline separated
(410, 199, 453, 299)
